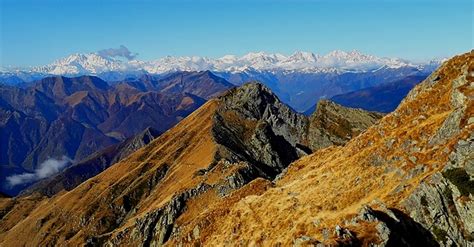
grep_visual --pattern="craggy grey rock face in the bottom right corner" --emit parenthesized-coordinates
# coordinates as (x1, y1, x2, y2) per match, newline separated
(404, 136, 474, 246)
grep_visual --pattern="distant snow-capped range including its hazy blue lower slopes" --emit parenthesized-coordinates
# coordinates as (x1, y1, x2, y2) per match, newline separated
(0, 51, 442, 111)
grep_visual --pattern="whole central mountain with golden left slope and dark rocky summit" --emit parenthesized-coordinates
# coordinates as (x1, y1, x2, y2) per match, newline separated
(0, 80, 377, 245)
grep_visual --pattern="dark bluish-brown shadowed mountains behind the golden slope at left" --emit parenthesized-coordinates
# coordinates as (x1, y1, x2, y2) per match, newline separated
(0, 72, 232, 194)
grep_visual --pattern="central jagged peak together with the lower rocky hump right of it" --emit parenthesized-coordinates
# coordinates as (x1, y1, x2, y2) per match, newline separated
(212, 83, 383, 179)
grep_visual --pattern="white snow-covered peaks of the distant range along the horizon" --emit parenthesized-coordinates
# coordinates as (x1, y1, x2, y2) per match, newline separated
(3, 50, 441, 75)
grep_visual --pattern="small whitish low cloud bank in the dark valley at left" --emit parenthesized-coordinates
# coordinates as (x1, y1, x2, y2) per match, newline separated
(7, 156, 71, 187)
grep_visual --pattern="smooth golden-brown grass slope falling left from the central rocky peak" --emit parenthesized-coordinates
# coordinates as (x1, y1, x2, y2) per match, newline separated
(0, 100, 217, 246)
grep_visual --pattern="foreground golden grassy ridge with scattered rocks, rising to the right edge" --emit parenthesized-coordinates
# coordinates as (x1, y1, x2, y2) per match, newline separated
(169, 51, 474, 246)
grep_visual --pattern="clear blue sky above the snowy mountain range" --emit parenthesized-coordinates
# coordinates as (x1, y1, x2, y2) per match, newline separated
(0, 0, 473, 66)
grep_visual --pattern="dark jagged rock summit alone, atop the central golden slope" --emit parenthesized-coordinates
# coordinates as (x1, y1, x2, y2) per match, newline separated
(212, 83, 308, 178)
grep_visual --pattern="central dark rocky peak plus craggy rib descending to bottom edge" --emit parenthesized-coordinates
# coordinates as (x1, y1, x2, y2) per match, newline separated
(102, 83, 316, 246)
